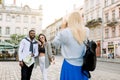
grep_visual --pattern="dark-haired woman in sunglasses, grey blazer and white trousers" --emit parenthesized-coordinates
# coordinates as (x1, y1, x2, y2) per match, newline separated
(38, 34, 54, 80)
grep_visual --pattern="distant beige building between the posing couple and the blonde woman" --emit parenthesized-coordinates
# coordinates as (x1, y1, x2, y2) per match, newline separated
(43, 18, 62, 55)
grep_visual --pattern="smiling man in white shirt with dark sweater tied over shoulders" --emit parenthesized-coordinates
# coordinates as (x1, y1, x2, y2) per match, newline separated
(18, 30, 38, 80)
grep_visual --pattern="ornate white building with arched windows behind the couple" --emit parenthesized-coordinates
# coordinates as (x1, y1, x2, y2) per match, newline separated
(0, 4, 42, 41)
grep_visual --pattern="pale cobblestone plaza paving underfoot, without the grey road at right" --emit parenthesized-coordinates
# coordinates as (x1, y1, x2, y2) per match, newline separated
(0, 56, 120, 80)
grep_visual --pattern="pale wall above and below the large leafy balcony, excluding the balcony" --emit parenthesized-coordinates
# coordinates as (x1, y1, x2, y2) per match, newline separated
(84, 0, 103, 41)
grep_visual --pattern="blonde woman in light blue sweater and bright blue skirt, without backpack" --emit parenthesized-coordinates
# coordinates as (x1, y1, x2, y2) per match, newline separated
(52, 12, 88, 80)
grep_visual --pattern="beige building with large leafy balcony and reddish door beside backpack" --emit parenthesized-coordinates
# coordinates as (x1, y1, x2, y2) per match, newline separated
(84, 0, 104, 57)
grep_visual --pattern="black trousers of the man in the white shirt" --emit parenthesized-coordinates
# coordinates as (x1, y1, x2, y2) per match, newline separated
(21, 63, 34, 80)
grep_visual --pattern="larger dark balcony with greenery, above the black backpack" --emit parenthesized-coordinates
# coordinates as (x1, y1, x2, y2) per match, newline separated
(85, 18, 102, 28)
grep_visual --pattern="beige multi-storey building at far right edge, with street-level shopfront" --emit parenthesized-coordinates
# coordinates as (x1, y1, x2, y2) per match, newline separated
(103, 0, 120, 57)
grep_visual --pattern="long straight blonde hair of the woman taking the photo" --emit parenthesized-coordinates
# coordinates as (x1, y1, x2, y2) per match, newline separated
(67, 11, 86, 44)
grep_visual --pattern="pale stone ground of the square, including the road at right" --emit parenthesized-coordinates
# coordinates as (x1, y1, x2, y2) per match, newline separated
(0, 56, 120, 80)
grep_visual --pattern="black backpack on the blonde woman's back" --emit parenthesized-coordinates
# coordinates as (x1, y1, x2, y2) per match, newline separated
(82, 40, 97, 78)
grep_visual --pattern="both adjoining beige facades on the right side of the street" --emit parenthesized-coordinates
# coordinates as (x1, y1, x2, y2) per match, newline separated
(84, 0, 120, 57)
